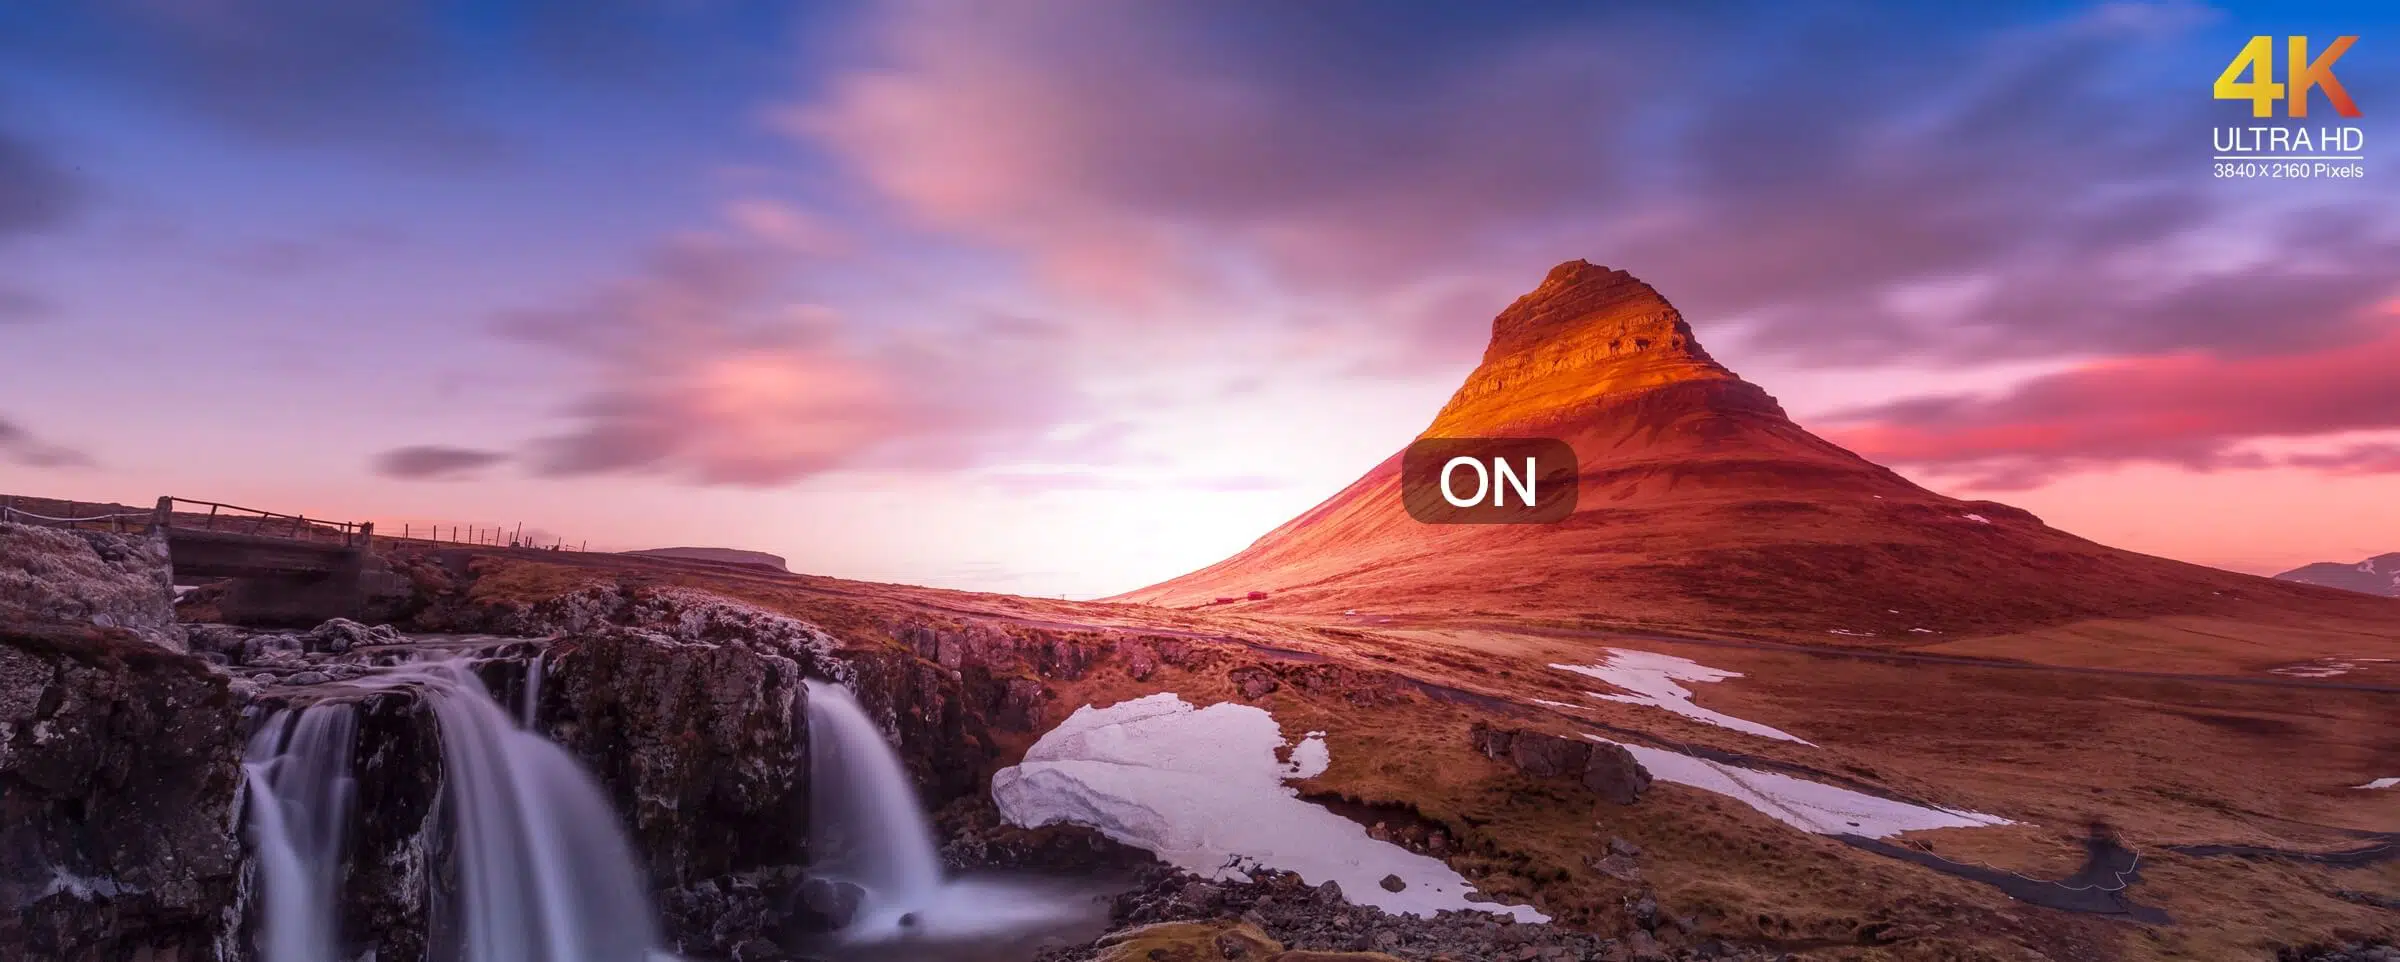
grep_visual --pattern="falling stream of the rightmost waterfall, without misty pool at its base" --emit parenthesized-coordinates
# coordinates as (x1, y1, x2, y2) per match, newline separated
(809, 679, 941, 904)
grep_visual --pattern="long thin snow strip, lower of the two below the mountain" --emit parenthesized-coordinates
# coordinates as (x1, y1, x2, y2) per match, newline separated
(1586, 734, 2009, 837)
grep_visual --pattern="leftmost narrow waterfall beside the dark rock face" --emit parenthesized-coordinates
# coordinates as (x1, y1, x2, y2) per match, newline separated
(242, 703, 358, 962)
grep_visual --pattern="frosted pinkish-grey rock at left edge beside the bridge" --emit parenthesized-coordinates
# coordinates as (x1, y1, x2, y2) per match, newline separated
(0, 521, 185, 653)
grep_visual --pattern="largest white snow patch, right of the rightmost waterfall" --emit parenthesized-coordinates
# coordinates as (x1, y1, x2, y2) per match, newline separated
(991, 691, 1548, 921)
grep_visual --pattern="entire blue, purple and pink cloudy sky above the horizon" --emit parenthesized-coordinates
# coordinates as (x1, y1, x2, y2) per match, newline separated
(0, 0, 2400, 597)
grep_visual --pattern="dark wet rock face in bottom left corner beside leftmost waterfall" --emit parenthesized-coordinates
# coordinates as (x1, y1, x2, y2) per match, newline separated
(0, 623, 242, 962)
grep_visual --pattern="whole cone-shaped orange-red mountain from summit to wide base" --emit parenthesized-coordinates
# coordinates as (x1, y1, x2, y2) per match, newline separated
(1118, 261, 2388, 643)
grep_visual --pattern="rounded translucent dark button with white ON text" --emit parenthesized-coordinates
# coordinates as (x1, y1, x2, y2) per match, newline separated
(1399, 437, 1577, 525)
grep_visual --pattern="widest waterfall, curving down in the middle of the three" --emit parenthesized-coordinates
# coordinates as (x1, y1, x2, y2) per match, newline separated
(374, 660, 658, 962)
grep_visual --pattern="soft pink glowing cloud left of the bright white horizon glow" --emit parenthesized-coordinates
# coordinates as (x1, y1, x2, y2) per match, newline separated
(480, 233, 1099, 487)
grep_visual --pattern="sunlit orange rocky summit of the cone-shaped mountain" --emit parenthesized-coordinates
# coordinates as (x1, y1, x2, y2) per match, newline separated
(1426, 261, 1738, 437)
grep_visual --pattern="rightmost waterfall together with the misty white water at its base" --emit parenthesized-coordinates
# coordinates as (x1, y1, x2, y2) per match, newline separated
(806, 679, 1094, 945)
